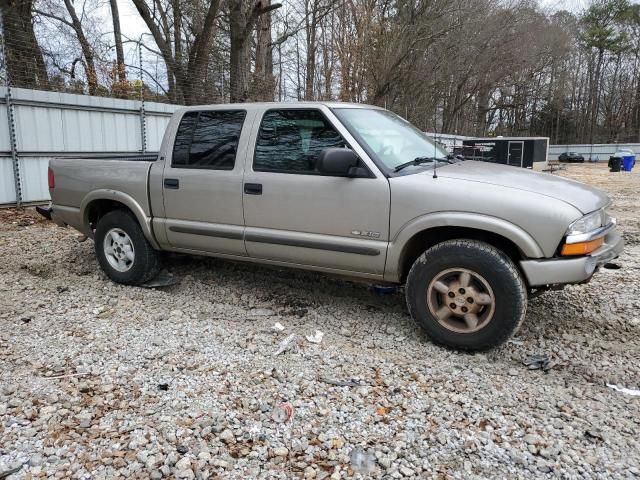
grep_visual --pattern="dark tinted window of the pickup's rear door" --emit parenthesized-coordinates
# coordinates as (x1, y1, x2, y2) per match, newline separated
(171, 110, 246, 170)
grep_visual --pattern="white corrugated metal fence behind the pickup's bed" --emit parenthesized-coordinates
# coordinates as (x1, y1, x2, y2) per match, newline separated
(0, 87, 179, 205)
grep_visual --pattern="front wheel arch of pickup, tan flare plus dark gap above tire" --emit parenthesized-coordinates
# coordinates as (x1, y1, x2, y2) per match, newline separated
(385, 212, 544, 283)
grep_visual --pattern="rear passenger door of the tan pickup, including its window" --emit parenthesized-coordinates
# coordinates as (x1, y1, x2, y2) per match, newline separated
(162, 109, 251, 256)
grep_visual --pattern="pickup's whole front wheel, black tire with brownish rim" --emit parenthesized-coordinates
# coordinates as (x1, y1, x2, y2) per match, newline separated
(405, 239, 527, 351)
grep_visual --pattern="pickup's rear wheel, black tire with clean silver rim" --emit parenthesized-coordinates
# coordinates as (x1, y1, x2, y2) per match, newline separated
(94, 210, 161, 285)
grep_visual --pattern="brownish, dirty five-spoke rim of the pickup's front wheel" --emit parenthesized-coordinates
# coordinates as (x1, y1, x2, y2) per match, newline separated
(426, 268, 495, 333)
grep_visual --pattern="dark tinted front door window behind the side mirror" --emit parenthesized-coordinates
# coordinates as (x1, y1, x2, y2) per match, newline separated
(253, 110, 348, 173)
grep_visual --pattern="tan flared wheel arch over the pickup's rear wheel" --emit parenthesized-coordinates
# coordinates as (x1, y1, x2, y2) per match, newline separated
(80, 189, 160, 250)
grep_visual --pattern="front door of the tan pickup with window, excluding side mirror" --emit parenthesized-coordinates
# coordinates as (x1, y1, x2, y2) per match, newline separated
(243, 107, 390, 277)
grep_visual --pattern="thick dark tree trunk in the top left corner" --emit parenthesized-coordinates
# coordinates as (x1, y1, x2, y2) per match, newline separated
(0, 0, 49, 88)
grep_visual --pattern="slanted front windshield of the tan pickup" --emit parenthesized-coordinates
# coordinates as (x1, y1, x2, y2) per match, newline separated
(334, 108, 447, 170)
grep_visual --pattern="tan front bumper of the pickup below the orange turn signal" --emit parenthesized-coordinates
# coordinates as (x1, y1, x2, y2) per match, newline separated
(520, 224, 624, 287)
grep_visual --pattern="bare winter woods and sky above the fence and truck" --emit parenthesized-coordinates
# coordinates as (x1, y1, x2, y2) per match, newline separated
(0, 0, 640, 144)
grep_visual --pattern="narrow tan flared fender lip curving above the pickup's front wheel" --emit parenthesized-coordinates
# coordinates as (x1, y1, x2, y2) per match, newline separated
(384, 212, 544, 282)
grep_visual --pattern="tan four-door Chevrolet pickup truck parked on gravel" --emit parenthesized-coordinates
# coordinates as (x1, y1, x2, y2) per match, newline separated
(40, 102, 623, 350)
